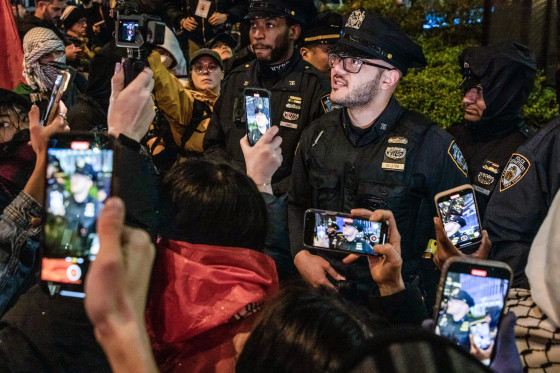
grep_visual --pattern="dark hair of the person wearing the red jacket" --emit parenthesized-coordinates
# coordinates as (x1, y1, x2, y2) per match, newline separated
(162, 159, 268, 251)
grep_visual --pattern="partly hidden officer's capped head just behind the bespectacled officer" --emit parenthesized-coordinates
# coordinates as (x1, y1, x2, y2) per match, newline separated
(299, 12, 342, 81)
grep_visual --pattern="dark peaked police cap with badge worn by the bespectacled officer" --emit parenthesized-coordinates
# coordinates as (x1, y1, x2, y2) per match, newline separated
(333, 8, 426, 75)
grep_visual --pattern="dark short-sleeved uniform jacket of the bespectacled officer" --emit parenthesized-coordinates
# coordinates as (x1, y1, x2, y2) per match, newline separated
(289, 98, 468, 284)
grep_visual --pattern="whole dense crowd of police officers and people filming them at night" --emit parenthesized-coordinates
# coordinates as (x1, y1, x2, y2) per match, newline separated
(0, 0, 560, 372)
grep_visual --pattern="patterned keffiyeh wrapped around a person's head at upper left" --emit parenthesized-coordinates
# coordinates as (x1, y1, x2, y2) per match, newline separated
(23, 27, 66, 92)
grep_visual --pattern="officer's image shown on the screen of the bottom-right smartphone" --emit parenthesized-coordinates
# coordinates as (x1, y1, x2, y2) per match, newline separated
(436, 289, 474, 351)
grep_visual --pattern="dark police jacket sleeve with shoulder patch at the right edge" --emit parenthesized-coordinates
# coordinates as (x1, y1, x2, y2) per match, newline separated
(484, 118, 560, 289)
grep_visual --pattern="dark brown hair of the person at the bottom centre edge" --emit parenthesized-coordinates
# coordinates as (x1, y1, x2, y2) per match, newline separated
(236, 283, 387, 373)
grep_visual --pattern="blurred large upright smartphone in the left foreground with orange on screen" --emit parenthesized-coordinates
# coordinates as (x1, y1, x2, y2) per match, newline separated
(41, 133, 113, 298)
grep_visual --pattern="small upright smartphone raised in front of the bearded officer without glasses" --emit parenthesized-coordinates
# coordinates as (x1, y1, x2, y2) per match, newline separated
(243, 88, 272, 146)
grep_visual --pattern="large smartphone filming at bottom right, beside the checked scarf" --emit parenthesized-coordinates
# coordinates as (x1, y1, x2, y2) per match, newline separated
(434, 257, 512, 363)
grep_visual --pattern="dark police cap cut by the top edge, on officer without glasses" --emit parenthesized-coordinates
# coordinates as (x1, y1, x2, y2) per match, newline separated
(245, 0, 317, 27)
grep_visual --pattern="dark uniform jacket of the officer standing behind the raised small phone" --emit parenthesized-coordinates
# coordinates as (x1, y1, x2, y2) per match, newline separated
(203, 52, 330, 194)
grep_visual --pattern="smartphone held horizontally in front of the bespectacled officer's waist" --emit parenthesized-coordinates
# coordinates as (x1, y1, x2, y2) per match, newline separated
(303, 209, 388, 255)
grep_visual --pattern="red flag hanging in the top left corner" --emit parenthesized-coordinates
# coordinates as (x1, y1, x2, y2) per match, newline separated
(0, 0, 23, 90)
